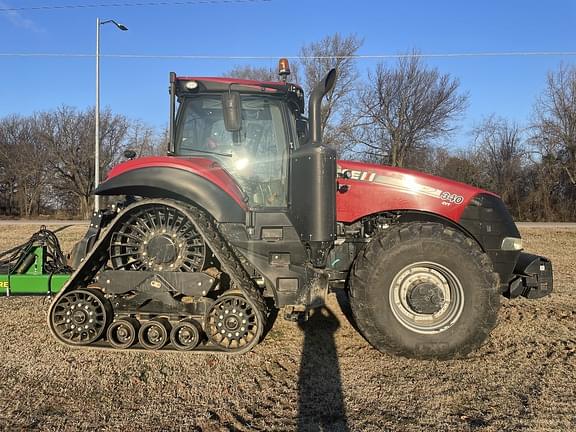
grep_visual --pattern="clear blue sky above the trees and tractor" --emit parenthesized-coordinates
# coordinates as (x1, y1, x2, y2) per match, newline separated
(0, 0, 576, 147)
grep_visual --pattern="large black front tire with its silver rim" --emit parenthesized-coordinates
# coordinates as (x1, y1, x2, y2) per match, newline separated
(349, 222, 500, 360)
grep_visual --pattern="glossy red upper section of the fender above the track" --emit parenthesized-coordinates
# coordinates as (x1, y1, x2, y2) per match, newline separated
(107, 156, 247, 209)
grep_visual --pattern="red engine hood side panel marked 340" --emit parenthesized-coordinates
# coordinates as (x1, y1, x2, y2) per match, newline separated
(336, 161, 486, 222)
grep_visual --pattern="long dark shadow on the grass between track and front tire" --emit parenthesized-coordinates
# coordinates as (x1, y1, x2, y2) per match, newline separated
(298, 307, 349, 432)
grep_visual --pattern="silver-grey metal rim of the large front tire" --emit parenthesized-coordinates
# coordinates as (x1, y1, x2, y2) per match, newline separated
(389, 261, 464, 334)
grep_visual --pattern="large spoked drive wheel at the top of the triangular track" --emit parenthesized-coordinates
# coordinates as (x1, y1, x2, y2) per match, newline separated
(110, 204, 206, 272)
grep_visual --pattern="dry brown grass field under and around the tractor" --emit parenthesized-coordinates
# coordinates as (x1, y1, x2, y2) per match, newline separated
(0, 226, 576, 431)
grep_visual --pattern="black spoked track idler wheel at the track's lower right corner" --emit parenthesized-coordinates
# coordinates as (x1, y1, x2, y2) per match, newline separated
(205, 294, 264, 353)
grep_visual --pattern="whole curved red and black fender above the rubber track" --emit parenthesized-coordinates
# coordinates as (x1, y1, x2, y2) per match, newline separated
(95, 157, 247, 223)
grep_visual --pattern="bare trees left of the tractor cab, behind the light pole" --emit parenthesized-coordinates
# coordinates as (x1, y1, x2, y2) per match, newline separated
(0, 106, 165, 218)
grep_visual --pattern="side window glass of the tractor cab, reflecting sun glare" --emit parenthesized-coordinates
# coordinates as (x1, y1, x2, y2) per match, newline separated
(176, 95, 288, 207)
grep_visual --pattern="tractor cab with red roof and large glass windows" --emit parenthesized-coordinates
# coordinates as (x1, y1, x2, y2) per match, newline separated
(171, 61, 307, 209)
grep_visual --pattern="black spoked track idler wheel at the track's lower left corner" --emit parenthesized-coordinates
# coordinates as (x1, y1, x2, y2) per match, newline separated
(50, 288, 112, 345)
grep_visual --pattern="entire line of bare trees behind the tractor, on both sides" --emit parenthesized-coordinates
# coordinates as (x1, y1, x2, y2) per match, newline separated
(0, 33, 576, 221)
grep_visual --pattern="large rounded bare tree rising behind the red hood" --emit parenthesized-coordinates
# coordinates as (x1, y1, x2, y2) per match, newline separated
(348, 56, 468, 166)
